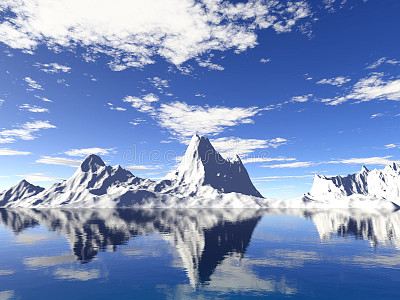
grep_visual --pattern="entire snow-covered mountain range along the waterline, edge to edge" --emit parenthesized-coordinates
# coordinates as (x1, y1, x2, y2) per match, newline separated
(0, 135, 400, 209)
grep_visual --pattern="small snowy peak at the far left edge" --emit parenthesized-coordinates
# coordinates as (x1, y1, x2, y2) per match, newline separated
(0, 179, 44, 207)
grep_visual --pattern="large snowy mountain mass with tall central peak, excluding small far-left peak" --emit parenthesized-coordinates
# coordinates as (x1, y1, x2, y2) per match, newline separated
(0, 135, 262, 208)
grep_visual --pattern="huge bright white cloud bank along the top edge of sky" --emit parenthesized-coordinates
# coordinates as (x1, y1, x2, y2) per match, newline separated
(0, 0, 312, 70)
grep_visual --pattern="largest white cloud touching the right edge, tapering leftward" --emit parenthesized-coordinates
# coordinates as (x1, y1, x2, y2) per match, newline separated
(322, 73, 400, 105)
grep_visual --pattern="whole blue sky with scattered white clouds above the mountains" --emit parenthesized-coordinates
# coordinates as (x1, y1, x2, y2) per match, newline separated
(0, 0, 400, 198)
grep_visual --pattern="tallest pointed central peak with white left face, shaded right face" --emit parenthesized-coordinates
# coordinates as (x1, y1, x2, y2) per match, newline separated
(159, 134, 262, 198)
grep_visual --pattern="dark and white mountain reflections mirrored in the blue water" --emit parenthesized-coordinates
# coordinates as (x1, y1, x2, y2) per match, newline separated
(0, 209, 400, 294)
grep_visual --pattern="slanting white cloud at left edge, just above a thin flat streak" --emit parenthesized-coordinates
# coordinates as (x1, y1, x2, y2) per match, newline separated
(0, 121, 56, 144)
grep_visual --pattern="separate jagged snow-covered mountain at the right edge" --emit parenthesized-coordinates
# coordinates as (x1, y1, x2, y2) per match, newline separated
(309, 162, 400, 205)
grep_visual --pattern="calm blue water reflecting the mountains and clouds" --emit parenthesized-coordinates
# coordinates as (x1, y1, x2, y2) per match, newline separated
(0, 209, 400, 299)
